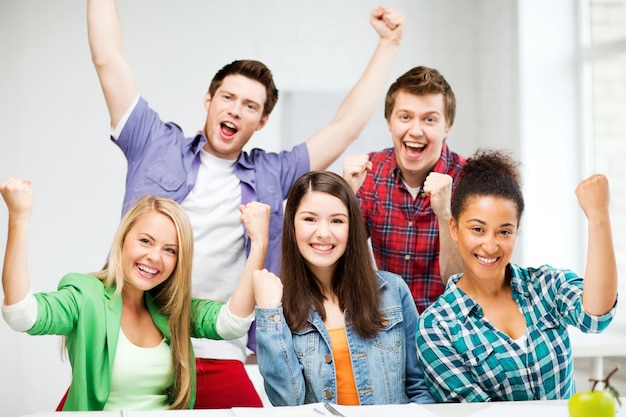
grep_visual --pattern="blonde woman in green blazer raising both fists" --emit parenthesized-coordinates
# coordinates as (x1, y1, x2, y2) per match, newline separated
(0, 178, 269, 411)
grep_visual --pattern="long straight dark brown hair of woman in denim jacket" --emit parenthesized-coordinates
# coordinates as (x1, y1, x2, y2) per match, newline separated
(281, 171, 383, 337)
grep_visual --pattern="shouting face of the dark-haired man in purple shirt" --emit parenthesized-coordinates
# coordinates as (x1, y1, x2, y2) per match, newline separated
(204, 74, 268, 160)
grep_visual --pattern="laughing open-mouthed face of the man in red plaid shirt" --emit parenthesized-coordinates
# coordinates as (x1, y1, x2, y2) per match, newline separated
(387, 90, 450, 187)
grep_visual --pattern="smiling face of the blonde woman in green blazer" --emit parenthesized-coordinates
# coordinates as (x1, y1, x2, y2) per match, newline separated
(122, 211, 178, 292)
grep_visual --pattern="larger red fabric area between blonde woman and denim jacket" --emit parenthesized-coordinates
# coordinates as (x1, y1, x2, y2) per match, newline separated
(193, 358, 263, 409)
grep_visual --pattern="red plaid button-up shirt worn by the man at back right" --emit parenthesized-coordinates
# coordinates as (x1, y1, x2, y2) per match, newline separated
(357, 144, 465, 313)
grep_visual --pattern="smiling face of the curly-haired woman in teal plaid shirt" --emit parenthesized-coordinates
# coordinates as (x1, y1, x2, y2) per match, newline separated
(450, 196, 519, 283)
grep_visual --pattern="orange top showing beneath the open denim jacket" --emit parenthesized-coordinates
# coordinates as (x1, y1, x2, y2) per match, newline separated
(328, 327, 360, 405)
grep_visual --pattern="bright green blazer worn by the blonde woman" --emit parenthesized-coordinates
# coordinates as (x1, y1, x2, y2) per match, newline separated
(28, 273, 224, 411)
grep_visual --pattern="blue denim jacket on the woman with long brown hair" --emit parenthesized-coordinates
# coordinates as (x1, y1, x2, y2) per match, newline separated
(256, 271, 434, 405)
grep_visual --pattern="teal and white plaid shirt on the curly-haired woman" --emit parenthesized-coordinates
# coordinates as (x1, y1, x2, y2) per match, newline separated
(417, 264, 617, 402)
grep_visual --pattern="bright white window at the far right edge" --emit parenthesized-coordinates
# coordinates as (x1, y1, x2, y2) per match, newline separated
(581, 0, 626, 308)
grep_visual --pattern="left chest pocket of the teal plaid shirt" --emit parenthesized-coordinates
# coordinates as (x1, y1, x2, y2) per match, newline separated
(461, 343, 506, 386)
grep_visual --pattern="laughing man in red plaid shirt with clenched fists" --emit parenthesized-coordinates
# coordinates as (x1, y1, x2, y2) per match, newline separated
(343, 66, 465, 313)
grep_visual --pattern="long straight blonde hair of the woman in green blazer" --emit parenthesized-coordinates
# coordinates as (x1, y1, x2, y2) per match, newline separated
(94, 195, 195, 409)
